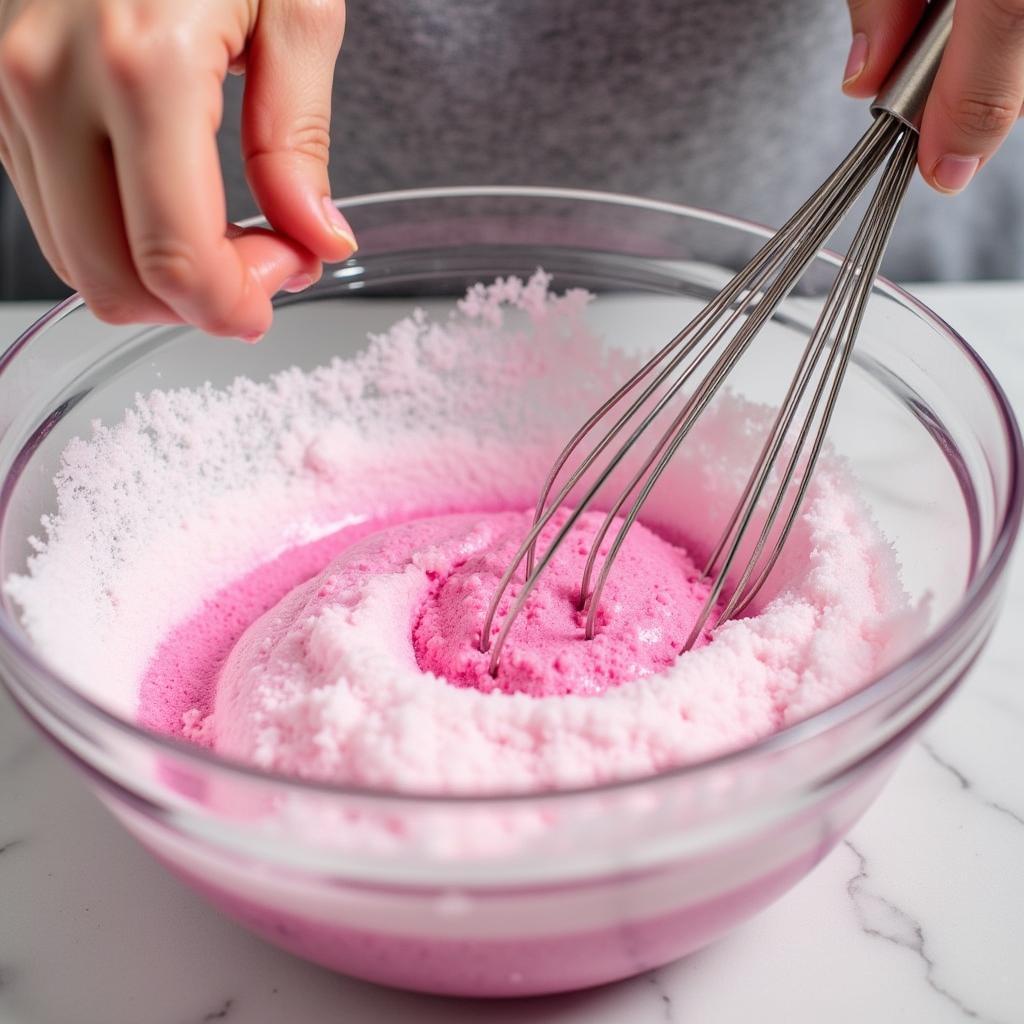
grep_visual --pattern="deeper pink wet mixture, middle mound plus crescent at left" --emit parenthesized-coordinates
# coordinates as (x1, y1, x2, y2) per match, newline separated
(138, 510, 720, 770)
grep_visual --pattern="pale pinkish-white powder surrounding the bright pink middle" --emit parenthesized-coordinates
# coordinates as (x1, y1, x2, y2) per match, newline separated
(5, 271, 912, 793)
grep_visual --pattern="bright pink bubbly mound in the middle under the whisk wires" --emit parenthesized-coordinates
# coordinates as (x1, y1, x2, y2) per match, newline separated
(413, 509, 709, 696)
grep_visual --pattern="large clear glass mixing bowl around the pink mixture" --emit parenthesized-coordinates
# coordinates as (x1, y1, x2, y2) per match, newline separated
(0, 188, 1021, 995)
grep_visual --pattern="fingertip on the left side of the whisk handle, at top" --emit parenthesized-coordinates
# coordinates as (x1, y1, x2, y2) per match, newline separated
(843, 0, 925, 97)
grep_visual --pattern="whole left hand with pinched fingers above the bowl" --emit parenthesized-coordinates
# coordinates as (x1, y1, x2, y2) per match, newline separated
(0, 0, 355, 340)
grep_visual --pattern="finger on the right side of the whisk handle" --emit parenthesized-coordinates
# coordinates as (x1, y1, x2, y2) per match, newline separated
(918, 0, 1024, 194)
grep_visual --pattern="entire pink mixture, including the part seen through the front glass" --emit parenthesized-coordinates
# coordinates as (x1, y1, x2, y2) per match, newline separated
(10, 274, 925, 995)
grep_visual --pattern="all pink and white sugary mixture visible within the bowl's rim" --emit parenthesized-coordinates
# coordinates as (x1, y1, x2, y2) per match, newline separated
(6, 272, 914, 793)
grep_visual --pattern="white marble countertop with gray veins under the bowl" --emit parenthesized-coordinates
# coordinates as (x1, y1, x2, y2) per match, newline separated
(0, 284, 1024, 1024)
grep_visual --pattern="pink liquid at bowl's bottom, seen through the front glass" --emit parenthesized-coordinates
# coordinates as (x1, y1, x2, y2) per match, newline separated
(109, 751, 895, 997)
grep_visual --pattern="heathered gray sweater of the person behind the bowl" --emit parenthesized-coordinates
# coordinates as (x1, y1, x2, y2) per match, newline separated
(0, 0, 1024, 298)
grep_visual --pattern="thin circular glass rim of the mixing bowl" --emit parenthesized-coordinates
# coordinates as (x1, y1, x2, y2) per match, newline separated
(0, 185, 1024, 807)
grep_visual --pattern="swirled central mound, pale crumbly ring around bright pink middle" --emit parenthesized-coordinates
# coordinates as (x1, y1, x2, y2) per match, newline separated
(210, 492, 905, 794)
